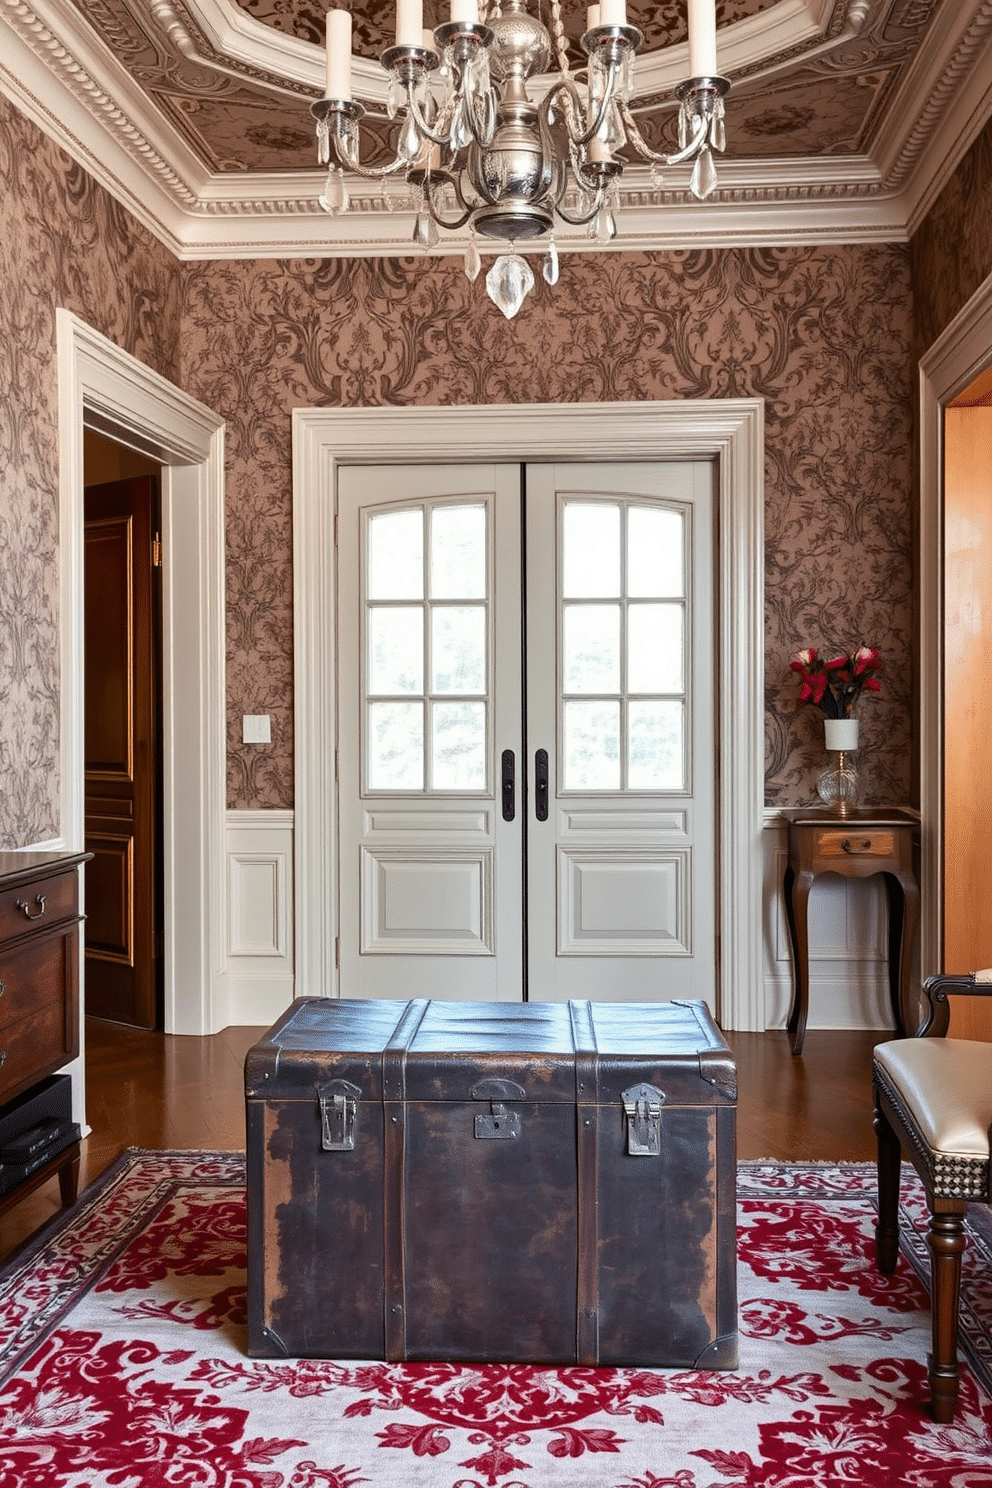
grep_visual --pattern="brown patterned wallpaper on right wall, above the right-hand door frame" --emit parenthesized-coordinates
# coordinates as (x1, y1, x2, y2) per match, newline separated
(910, 122, 992, 357)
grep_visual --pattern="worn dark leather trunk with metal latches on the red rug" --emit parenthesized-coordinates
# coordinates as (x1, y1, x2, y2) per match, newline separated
(245, 998, 738, 1369)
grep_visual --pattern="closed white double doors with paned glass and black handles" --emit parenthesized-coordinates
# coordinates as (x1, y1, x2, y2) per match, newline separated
(338, 461, 717, 1007)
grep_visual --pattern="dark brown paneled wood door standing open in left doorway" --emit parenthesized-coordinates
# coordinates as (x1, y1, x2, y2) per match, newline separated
(85, 476, 161, 1028)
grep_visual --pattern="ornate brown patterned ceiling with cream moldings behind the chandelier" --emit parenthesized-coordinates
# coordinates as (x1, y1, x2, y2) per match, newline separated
(0, 0, 992, 259)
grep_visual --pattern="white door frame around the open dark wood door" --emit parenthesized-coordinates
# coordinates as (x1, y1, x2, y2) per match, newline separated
(57, 310, 226, 1041)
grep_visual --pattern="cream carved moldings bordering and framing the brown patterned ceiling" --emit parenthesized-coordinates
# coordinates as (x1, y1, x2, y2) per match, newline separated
(0, 0, 992, 260)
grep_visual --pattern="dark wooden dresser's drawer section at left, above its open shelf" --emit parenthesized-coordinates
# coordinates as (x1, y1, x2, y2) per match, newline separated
(0, 853, 89, 1103)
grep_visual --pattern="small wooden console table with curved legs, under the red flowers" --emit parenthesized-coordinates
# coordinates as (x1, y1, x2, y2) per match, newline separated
(782, 806, 919, 1054)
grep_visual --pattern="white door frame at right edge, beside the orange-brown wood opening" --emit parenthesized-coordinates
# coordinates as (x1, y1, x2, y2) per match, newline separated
(919, 275, 992, 981)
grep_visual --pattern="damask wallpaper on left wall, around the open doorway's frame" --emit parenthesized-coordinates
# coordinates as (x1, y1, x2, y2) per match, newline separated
(0, 98, 180, 848)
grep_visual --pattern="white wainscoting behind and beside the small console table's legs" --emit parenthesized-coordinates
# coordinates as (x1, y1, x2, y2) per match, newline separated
(763, 811, 892, 1028)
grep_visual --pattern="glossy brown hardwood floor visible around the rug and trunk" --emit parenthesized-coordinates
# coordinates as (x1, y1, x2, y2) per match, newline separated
(0, 1019, 889, 1262)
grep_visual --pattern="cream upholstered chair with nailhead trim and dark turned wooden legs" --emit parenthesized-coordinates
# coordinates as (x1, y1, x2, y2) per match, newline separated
(873, 970, 992, 1421)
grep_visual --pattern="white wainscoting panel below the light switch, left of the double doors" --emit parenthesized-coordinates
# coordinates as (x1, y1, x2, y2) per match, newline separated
(223, 811, 294, 1027)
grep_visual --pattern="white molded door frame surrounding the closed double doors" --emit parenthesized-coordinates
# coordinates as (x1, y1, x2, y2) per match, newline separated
(293, 399, 764, 1030)
